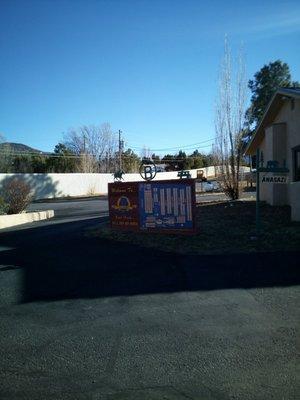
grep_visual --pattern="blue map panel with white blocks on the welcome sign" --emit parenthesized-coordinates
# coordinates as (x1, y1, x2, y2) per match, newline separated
(139, 180, 194, 231)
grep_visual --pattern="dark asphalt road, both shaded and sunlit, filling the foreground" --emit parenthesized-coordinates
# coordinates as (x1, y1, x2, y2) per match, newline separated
(0, 198, 300, 400)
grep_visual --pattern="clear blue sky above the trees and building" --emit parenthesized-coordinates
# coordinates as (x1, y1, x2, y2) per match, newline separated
(0, 0, 300, 152)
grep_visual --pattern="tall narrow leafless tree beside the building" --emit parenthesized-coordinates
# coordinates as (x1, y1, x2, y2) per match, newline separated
(214, 38, 247, 200)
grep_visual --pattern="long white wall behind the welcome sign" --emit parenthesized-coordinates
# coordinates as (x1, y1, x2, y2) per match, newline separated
(0, 167, 251, 200)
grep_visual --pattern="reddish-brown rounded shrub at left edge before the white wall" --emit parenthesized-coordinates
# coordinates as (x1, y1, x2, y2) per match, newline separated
(2, 178, 32, 214)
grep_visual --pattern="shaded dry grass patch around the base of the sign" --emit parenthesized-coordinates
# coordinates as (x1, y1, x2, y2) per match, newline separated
(90, 201, 300, 254)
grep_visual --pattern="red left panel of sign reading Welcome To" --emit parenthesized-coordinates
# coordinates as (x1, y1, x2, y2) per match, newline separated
(108, 182, 139, 230)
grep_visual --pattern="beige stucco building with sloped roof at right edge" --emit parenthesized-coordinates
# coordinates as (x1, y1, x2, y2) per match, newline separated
(246, 88, 300, 221)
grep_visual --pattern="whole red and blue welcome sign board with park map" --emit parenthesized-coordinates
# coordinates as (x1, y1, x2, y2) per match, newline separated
(108, 179, 195, 233)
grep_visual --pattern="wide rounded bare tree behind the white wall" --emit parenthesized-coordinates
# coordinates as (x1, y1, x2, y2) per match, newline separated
(64, 123, 117, 172)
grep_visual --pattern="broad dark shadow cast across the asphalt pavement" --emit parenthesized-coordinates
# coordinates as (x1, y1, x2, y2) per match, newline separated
(0, 220, 300, 302)
